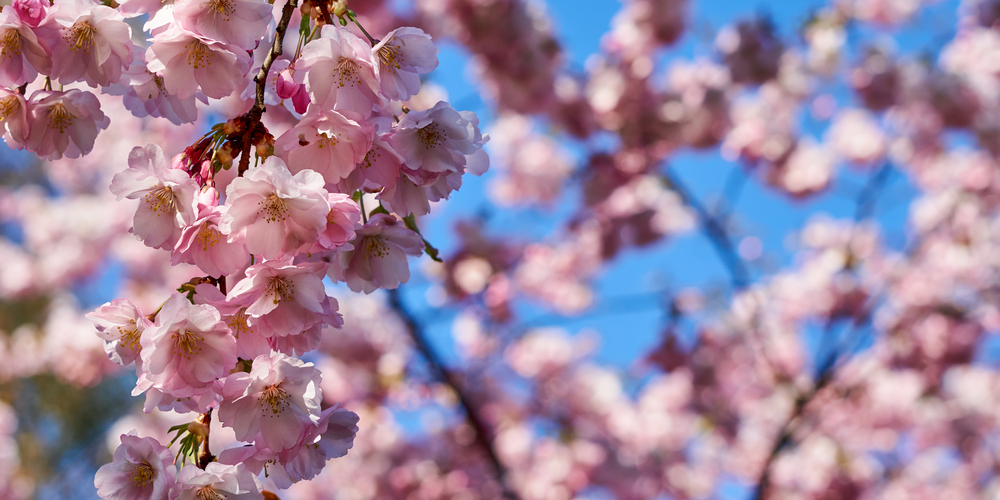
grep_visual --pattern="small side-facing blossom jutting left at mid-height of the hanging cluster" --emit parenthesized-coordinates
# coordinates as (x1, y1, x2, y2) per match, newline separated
(86, 299, 153, 366)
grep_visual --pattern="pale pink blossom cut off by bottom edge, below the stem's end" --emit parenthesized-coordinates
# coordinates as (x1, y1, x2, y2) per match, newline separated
(173, 462, 264, 500)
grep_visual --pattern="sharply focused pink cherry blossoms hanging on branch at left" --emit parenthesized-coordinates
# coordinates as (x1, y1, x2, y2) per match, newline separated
(0, 0, 489, 500)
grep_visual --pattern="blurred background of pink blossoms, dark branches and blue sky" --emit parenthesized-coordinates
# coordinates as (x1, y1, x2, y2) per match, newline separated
(0, 0, 1000, 500)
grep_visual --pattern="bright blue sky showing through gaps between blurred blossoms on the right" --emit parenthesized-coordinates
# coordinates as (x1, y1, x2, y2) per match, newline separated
(406, 0, 958, 370)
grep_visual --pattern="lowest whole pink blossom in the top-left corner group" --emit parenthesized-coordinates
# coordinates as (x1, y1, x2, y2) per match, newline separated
(27, 89, 111, 160)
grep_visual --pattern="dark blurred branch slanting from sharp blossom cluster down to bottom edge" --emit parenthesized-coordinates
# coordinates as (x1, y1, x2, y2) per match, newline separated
(387, 289, 519, 500)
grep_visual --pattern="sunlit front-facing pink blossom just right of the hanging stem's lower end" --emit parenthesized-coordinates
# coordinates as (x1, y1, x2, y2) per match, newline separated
(219, 354, 322, 453)
